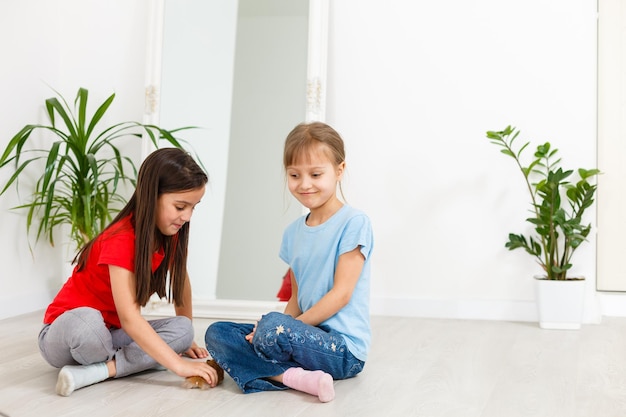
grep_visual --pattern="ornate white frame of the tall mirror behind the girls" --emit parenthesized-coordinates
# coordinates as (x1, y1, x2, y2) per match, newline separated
(142, 0, 329, 320)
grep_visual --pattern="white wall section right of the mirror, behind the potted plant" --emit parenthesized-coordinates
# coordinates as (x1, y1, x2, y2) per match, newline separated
(327, 0, 596, 320)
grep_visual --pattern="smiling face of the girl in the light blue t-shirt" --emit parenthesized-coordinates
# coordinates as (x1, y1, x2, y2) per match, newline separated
(286, 145, 345, 211)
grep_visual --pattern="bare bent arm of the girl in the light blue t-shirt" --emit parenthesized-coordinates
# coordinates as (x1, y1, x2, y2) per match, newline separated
(289, 247, 365, 326)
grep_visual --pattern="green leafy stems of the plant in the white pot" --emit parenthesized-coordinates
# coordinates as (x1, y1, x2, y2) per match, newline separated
(487, 126, 600, 280)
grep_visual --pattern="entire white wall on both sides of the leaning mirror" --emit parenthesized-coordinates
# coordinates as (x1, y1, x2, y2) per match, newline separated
(0, 0, 608, 321)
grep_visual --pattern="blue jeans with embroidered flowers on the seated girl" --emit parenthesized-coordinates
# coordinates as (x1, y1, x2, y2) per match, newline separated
(204, 312, 365, 393)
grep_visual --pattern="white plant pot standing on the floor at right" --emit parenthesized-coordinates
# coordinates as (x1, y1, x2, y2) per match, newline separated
(535, 277, 585, 330)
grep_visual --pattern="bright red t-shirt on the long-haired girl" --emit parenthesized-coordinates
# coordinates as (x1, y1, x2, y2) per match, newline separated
(43, 216, 164, 328)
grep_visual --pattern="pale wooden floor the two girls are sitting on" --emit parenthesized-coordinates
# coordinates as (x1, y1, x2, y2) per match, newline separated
(0, 312, 626, 417)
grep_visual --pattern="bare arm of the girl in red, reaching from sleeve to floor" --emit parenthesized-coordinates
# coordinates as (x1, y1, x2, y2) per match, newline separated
(109, 265, 217, 387)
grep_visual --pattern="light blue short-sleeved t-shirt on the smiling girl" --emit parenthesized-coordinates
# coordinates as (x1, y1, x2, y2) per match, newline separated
(280, 205, 374, 361)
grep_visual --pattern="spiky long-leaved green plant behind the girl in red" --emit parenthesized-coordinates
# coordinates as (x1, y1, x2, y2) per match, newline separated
(0, 88, 195, 248)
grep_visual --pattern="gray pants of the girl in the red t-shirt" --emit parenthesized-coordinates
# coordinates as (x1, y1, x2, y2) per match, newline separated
(39, 307, 193, 378)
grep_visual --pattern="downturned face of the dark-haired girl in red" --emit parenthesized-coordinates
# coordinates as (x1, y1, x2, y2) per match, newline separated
(156, 187, 205, 236)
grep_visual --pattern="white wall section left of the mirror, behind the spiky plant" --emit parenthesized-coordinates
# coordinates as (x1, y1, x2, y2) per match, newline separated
(0, 0, 150, 318)
